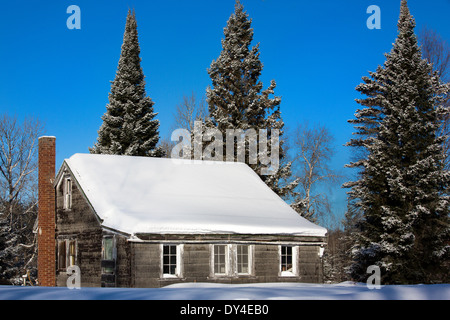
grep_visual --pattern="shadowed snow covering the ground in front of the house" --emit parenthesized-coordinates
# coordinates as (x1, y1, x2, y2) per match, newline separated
(0, 282, 450, 300)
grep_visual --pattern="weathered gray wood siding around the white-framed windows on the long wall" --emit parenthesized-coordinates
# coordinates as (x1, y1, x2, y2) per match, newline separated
(130, 242, 322, 288)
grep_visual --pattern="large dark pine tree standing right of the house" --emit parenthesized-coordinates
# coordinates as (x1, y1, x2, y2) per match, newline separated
(345, 0, 450, 284)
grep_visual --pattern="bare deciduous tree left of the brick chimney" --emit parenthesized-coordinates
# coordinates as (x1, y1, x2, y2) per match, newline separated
(0, 114, 43, 283)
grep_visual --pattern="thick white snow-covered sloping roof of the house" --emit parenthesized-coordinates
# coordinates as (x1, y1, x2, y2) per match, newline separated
(61, 154, 327, 236)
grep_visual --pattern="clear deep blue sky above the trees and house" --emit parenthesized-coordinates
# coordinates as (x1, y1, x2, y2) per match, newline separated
(0, 0, 450, 225)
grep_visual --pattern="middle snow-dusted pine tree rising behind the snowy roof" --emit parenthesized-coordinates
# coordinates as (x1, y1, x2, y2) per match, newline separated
(206, 1, 295, 196)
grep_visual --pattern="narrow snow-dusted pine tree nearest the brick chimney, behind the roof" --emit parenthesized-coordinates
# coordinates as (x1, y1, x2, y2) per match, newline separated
(90, 11, 163, 157)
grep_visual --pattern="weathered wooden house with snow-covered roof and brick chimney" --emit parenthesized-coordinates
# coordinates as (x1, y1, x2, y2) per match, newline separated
(37, 137, 327, 287)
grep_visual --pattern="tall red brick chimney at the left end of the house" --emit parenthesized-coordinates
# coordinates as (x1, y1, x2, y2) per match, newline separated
(38, 137, 56, 287)
